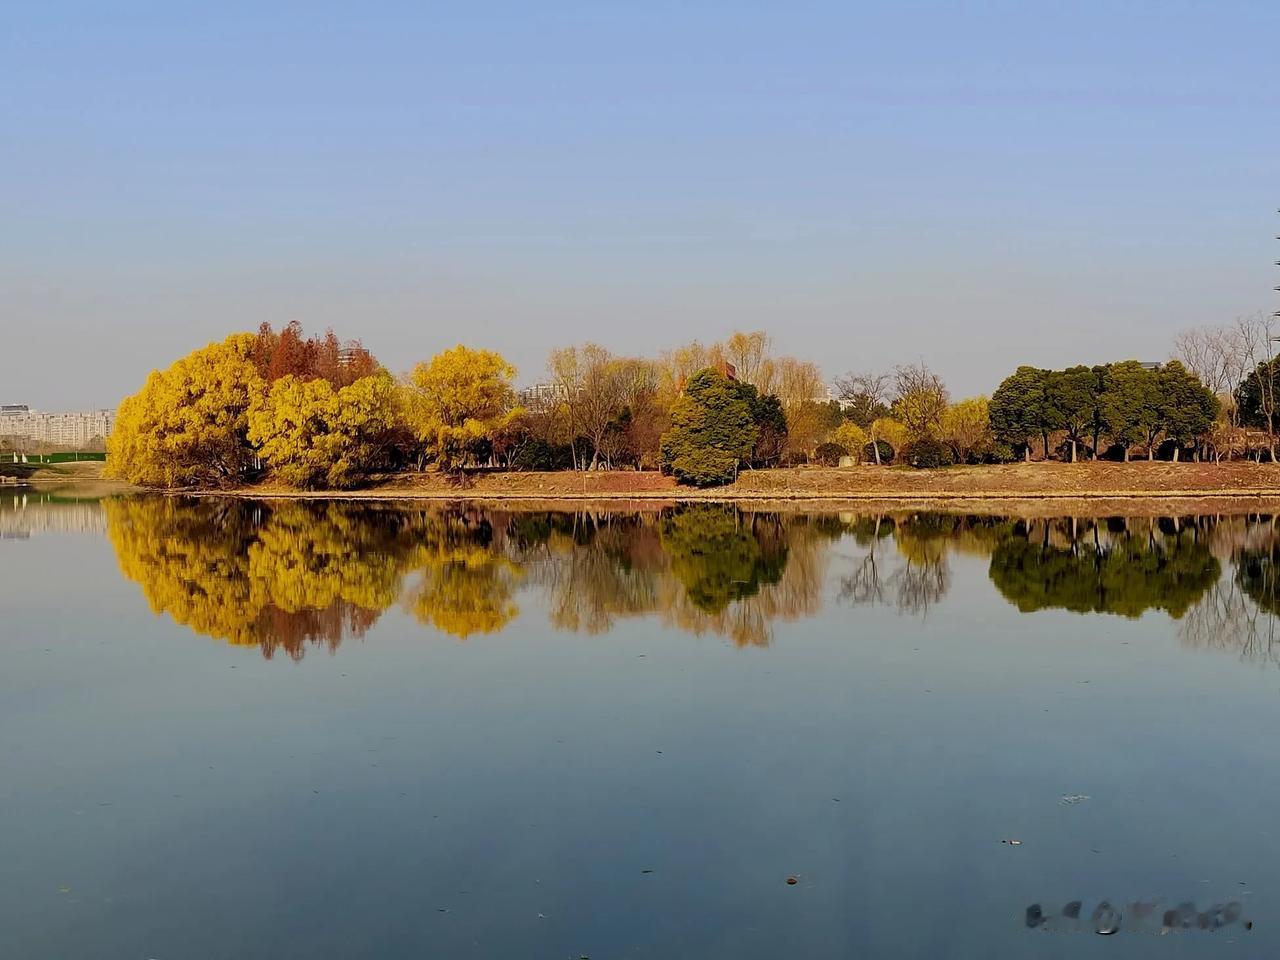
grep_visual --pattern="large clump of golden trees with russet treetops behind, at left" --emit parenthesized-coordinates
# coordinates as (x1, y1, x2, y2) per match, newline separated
(108, 325, 402, 489)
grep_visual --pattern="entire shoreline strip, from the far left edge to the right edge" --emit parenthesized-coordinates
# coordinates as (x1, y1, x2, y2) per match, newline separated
(30, 461, 1280, 515)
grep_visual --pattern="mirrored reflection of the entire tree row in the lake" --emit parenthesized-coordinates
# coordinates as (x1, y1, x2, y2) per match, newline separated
(82, 497, 1280, 663)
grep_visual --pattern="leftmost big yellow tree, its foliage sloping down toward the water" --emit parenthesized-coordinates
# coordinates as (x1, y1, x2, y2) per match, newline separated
(108, 334, 265, 486)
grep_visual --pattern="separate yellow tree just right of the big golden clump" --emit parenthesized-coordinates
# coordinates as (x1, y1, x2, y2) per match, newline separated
(406, 344, 520, 471)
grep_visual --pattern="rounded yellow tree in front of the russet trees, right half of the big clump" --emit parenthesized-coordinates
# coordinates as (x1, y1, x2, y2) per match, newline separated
(248, 374, 398, 489)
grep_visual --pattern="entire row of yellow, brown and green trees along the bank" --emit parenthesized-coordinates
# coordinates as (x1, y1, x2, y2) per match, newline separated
(109, 317, 1280, 489)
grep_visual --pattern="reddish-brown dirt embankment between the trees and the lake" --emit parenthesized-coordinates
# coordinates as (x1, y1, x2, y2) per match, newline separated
(199, 462, 1280, 511)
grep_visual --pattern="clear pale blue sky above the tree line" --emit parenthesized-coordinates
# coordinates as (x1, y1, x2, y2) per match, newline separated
(0, 0, 1280, 410)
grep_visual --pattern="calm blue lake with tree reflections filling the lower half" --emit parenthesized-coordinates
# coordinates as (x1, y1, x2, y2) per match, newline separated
(0, 492, 1280, 960)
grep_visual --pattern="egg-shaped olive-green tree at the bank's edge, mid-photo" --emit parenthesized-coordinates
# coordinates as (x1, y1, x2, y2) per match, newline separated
(662, 367, 756, 486)
